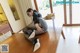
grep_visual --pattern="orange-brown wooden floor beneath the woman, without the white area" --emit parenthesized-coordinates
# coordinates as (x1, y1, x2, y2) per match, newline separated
(1, 26, 58, 53)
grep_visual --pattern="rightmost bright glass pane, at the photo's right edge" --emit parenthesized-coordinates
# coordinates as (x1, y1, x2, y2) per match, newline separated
(72, 0, 80, 24)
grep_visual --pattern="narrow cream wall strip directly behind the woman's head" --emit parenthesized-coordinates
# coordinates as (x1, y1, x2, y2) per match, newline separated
(18, 0, 33, 25)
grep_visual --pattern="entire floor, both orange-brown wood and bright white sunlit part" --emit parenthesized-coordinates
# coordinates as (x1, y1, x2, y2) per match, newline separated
(1, 20, 80, 53)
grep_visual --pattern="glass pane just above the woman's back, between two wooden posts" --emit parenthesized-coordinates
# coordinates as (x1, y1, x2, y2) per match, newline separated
(37, 0, 51, 17)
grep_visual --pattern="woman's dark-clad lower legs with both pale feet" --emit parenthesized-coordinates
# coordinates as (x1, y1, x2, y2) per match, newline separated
(23, 28, 40, 52)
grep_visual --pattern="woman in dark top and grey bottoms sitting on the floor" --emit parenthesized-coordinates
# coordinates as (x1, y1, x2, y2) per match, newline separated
(23, 8, 47, 51)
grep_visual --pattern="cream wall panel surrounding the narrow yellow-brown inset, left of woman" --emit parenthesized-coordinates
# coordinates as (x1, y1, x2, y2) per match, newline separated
(0, 0, 26, 33)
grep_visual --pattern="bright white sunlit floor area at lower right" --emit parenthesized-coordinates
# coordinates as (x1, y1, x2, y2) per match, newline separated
(56, 27, 80, 53)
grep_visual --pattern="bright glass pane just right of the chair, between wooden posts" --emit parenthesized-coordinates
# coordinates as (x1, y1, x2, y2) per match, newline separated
(52, 0, 64, 26)
